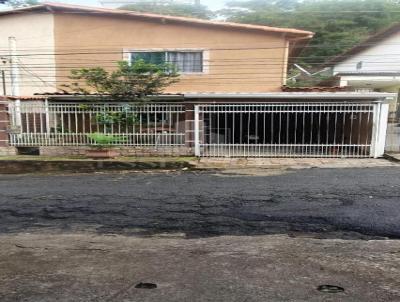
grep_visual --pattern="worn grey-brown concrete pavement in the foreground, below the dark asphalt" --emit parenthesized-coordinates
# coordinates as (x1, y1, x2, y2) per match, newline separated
(0, 234, 400, 302)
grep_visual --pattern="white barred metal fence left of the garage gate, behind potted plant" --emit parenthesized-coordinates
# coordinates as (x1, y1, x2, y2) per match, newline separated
(9, 102, 185, 146)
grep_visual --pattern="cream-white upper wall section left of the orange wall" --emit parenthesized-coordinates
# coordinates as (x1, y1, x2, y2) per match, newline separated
(0, 13, 56, 96)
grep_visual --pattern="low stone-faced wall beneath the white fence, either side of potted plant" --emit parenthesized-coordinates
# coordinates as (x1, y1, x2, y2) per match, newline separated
(40, 146, 193, 157)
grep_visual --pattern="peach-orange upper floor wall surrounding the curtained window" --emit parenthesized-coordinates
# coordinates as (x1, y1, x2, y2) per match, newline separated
(55, 14, 289, 93)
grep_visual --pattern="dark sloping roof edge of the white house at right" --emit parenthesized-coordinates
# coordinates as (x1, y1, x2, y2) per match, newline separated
(324, 23, 400, 66)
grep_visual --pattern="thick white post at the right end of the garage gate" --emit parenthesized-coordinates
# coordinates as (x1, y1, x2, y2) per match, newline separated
(371, 101, 389, 158)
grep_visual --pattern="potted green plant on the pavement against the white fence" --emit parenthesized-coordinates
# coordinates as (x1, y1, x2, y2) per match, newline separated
(86, 133, 122, 159)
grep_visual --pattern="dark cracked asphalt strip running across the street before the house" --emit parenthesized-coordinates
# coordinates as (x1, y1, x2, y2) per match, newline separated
(0, 167, 400, 239)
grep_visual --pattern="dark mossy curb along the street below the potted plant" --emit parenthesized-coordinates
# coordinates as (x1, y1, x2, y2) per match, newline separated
(0, 160, 195, 174)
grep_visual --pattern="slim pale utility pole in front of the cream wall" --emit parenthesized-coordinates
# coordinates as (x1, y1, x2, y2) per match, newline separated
(8, 37, 22, 127)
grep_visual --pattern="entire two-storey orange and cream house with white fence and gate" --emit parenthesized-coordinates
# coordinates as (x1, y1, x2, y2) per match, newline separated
(0, 3, 393, 157)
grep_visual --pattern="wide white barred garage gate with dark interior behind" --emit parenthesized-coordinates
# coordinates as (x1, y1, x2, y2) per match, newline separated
(195, 102, 388, 158)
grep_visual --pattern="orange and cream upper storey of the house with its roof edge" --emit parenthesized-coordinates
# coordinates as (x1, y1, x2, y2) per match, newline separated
(0, 3, 313, 95)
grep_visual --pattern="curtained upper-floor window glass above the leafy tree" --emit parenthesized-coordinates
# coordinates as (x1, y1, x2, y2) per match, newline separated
(130, 51, 203, 73)
